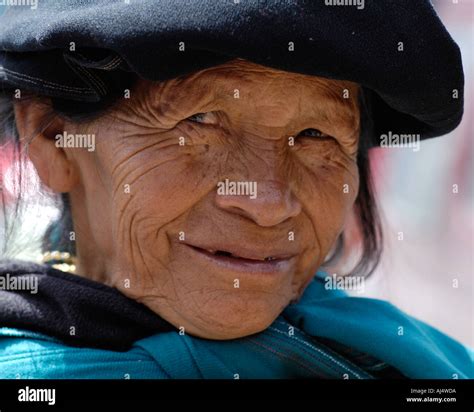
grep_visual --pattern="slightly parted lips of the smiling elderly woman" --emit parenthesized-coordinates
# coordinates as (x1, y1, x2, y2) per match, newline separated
(185, 244, 294, 273)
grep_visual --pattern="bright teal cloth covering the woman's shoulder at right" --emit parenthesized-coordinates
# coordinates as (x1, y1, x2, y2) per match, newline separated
(283, 276, 474, 379)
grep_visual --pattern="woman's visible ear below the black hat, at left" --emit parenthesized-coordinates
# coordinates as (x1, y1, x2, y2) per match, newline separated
(14, 99, 77, 193)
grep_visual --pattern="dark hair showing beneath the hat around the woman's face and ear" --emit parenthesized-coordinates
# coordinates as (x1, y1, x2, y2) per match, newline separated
(0, 77, 383, 277)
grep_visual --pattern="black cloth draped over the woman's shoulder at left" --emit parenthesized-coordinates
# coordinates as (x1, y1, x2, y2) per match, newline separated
(0, 261, 172, 351)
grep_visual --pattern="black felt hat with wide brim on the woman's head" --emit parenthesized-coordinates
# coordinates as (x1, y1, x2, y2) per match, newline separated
(0, 0, 464, 145)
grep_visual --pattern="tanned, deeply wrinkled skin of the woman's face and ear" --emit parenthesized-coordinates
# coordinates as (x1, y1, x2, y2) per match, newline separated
(15, 60, 359, 339)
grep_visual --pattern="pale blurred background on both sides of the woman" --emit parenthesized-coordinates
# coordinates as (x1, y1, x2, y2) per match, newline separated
(0, 0, 474, 346)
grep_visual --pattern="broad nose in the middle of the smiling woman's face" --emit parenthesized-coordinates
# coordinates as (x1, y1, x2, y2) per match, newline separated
(216, 179, 301, 227)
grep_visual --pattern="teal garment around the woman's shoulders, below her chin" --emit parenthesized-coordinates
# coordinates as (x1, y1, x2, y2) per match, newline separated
(0, 272, 474, 379)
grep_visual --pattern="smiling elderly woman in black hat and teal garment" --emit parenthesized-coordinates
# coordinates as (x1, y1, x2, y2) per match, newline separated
(0, 0, 470, 379)
